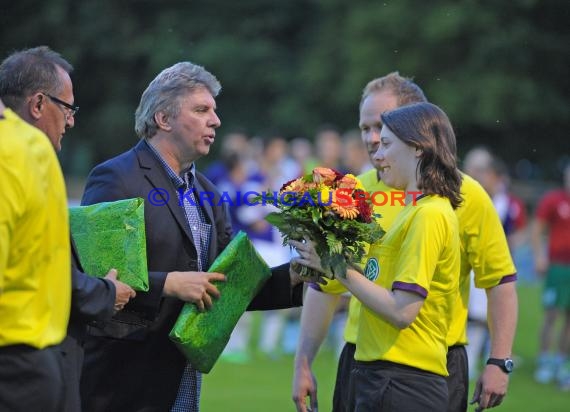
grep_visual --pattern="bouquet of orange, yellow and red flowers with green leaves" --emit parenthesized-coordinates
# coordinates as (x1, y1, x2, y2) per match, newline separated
(265, 167, 384, 278)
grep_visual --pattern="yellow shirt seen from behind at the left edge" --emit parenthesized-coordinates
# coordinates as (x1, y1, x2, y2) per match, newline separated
(0, 109, 71, 349)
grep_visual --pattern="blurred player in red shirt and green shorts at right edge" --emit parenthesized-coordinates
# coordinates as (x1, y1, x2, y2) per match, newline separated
(532, 163, 570, 390)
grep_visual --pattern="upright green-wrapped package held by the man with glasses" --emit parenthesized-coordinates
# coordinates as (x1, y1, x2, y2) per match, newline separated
(69, 198, 148, 292)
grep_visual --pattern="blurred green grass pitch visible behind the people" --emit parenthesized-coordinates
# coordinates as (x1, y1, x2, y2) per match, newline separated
(201, 283, 570, 412)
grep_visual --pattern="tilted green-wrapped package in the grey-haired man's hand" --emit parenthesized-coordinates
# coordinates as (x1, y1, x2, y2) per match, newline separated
(169, 231, 271, 373)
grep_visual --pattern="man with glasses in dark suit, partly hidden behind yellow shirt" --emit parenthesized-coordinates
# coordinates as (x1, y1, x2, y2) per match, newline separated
(0, 46, 135, 412)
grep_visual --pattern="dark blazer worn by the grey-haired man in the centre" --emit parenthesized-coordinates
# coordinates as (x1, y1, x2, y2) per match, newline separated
(81, 140, 302, 412)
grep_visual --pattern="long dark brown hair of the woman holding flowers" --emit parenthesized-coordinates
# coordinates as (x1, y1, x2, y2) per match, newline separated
(381, 103, 462, 209)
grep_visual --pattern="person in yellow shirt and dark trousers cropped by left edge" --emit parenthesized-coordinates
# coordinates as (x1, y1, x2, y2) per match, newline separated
(0, 100, 71, 412)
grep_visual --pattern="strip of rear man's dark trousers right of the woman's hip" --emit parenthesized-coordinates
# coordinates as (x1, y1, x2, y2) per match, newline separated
(447, 345, 469, 412)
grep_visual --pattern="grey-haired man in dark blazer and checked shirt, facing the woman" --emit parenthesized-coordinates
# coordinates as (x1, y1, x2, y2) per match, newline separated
(81, 62, 302, 412)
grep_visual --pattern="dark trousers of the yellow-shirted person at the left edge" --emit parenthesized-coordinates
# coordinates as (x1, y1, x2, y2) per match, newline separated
(0, 345, 64, 412)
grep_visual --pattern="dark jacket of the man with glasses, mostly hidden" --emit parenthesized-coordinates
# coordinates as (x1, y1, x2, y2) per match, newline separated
(59, 237, 115, 412)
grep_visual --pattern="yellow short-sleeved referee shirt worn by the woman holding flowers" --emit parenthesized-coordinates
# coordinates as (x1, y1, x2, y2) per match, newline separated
(354, 196, 460, 376)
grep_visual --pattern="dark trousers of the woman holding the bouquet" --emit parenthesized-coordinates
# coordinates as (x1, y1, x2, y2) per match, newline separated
(349, 361, 448, 412)
